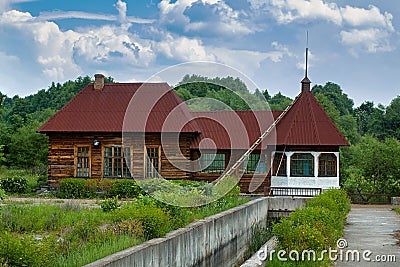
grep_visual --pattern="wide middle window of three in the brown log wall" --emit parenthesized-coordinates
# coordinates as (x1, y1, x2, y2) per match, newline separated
(104, 146, 132, 178)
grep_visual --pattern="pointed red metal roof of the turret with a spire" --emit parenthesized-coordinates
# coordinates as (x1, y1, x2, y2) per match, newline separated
(276, 91, 349, 146)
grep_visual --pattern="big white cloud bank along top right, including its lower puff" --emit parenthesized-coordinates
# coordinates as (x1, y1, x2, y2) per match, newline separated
(248, 0, 395, 53)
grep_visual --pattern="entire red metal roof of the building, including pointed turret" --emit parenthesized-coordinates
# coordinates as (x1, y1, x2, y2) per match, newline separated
(38, 83, 349, 149)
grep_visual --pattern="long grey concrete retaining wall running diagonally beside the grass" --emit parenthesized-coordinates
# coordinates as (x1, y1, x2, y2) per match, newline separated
(86, 197, 269, 267)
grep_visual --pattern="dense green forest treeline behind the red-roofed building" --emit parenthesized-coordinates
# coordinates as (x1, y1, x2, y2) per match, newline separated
(0, 75, 400, 194)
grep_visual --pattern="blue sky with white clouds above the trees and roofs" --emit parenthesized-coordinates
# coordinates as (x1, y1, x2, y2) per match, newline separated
(0, 0, 400, 106)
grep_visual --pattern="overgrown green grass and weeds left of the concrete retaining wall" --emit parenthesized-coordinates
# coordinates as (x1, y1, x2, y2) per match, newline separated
(0, 184, 248, 266)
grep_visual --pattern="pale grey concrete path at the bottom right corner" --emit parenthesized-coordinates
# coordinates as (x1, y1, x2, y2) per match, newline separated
(335, 205, 400, 267)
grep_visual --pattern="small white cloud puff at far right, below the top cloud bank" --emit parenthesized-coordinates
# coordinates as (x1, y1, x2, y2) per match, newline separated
(340, 28, 393, 55)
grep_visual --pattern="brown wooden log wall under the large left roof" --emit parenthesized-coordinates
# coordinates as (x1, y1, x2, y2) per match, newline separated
(48, 133, 193, 182)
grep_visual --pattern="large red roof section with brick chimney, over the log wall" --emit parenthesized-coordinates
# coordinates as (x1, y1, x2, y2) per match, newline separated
(38, 83, 199, 133)
